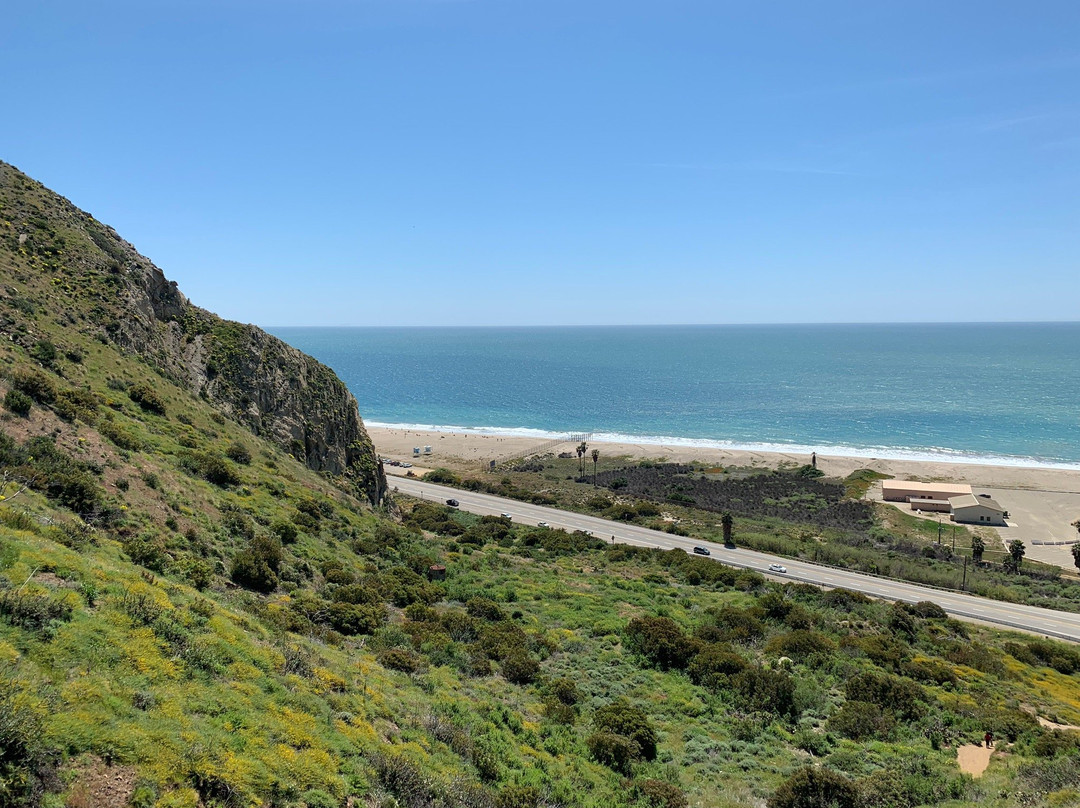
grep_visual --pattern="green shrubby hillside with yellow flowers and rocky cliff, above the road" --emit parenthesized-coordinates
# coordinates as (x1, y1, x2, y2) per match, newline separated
(0, 165, 1080, 808)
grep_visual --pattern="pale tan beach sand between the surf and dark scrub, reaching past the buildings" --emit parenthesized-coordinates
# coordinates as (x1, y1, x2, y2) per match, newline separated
(367, 427, 1080, 569)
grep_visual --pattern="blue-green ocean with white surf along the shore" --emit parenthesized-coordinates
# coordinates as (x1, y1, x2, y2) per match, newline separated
(270, 323, 1080, 468)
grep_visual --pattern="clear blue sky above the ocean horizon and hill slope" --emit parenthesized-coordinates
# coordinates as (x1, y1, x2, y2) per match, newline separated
(0, 0, 1080, 326)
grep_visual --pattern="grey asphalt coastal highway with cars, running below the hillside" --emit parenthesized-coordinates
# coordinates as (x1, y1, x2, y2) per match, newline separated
(388, 476, 1080, 642)
